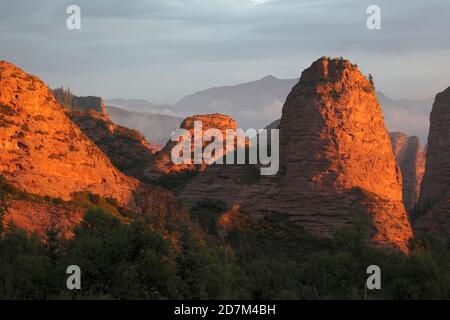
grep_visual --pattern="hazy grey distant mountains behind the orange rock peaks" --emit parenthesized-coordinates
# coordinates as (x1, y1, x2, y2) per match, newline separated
(105, 75, 433, 145)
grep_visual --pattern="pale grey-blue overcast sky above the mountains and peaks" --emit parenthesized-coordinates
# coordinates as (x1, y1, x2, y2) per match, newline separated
(0, 0, 450, 103)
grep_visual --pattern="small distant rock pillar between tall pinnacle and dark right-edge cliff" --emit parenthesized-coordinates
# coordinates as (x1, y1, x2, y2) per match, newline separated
(389, 132, 425, 210)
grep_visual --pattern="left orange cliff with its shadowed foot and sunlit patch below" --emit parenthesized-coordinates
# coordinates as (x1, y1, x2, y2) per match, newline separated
(0, 62, 187, 233)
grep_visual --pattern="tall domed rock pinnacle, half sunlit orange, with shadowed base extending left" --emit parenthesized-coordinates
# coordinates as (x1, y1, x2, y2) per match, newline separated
(180, 58, 412, 252)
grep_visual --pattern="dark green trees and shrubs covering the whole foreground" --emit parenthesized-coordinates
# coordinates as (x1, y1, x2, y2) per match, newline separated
(0, 190, 450, 299)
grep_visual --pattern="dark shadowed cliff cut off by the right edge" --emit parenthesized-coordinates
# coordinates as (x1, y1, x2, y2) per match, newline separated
(416, 87, 450, 236)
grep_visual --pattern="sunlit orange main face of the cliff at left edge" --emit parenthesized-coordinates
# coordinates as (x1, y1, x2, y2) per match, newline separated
(0, 62, 137, 204)
